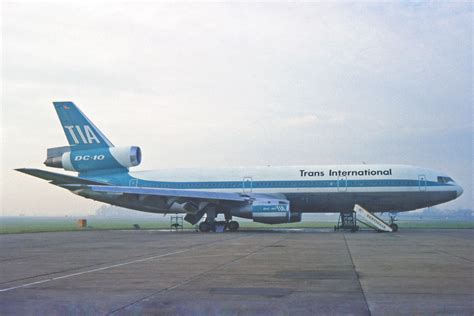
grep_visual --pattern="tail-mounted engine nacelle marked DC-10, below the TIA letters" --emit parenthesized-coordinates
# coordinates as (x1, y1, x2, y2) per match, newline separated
(44, 146, 142, 172)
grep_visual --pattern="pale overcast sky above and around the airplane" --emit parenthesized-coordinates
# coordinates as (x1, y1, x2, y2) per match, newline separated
(1, 2, 473, 216)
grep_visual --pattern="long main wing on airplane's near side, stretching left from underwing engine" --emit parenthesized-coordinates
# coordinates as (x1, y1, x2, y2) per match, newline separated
(67, 184, 254, 202)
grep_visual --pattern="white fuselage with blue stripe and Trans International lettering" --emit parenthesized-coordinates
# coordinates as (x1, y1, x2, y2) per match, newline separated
(122, 164, 462, 212)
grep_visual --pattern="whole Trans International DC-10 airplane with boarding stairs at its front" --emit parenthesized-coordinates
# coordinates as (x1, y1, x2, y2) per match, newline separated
(16, 101, 463, 232)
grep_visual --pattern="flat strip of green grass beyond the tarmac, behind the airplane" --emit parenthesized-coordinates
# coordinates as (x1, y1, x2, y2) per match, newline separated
(0, 217, 474, 234)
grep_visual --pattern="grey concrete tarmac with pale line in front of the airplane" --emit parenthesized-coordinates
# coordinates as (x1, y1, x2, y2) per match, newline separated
(0, 229, 474, 315)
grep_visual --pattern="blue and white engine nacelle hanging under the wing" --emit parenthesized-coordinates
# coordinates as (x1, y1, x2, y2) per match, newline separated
(251, 198, 291, 224)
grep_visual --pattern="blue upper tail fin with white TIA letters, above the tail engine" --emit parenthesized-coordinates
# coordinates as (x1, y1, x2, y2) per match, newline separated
(53, 102, 114, 151)
